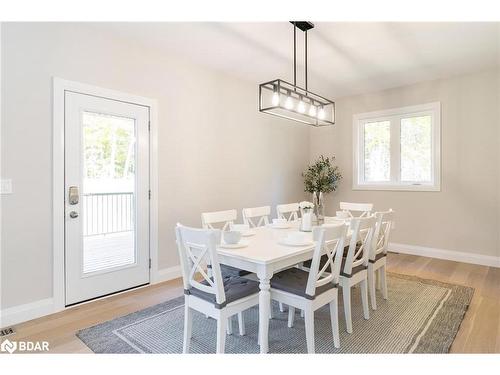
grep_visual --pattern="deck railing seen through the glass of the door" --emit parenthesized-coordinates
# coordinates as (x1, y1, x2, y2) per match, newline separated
(82, 193, 134, 236)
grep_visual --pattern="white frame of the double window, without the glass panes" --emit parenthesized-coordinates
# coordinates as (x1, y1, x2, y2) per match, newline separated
(352, 102, 441, 191)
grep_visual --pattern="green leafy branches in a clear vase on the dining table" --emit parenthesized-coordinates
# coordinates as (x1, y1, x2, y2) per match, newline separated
(302, 155, 342, 222)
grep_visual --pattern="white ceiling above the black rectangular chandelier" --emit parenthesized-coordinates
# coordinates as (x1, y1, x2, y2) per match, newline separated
(93, 22, 500, 99)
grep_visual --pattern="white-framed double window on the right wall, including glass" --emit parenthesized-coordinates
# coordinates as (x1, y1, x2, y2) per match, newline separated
(353, 102, 441, 191)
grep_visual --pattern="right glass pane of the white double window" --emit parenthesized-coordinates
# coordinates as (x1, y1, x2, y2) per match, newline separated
(401, 116, 432, 182)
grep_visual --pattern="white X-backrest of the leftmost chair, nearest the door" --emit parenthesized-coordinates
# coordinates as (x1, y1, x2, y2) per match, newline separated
(175, 223, 226, 305)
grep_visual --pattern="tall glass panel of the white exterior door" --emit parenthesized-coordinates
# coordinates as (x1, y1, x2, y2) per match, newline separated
(81, 112, 136, 273)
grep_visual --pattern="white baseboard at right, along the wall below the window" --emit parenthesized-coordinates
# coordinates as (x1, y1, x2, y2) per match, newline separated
(389, 242, 500, 268)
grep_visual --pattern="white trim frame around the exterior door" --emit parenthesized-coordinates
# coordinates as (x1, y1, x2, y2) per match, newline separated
(52, 77, 159, 312)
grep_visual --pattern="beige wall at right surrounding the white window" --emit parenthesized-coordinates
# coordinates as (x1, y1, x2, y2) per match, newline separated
(311, 70, 500, 256)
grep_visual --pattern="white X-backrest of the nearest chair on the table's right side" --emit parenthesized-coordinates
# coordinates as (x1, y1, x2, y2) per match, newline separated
(306, 224, 348, 297)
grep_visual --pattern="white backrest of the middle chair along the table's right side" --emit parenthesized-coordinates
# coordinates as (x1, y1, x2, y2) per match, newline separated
(341, 216, 376, 275)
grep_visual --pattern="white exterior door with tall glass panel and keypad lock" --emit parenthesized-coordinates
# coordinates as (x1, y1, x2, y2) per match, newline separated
(64, 91, 150, 306)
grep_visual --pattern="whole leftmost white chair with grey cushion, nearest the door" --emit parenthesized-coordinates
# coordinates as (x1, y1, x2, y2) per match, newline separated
(176, 224, 259, 353)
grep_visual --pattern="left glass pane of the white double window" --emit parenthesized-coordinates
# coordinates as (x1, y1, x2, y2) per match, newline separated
(364, 121, 391, 182)
